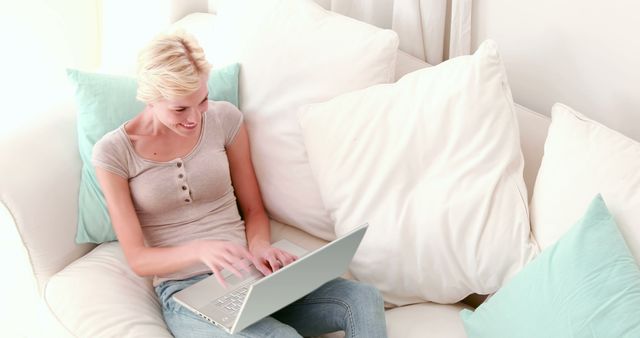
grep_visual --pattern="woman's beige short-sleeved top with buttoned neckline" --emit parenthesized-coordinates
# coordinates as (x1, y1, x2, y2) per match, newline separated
(92, 101, 246, 285)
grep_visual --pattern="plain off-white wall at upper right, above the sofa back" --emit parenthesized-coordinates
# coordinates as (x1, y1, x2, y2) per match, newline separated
(471, 0, 640, 140)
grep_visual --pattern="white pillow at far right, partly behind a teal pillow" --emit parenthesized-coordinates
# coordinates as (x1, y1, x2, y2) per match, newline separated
(531, 104, 640, 262)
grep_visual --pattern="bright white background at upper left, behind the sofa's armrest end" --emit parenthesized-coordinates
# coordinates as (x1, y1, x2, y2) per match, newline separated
(0, 0, 208, 139)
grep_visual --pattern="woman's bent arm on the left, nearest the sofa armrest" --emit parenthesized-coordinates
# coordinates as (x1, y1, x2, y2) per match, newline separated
(96, 167, 252, 285)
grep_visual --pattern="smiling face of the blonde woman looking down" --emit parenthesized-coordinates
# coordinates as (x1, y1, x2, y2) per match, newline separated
(150, 74, 209, 136)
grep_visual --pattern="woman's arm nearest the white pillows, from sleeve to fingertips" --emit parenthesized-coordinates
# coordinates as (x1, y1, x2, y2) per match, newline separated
(227, 123, 296, 275)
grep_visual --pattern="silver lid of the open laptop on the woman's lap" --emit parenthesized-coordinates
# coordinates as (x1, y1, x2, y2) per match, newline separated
(231, 223, 369, 333)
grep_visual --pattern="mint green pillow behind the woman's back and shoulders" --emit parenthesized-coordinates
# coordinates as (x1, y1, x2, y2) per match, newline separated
(67, 64, 240, 243)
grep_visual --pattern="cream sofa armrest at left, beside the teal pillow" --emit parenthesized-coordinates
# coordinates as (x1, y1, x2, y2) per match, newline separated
(0, 98, 94, 293)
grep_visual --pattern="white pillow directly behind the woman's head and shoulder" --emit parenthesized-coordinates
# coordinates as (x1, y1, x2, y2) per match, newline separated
(205, 0, 398, 239)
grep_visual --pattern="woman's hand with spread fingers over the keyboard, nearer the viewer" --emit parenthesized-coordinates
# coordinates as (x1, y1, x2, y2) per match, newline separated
(193, 240, 254, 288)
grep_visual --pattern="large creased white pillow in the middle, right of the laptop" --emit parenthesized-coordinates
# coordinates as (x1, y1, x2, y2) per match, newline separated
(300, 42, 536, 305)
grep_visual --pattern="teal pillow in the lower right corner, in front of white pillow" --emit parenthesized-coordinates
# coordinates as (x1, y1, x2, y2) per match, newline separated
(460, 195, 640, 338)
